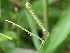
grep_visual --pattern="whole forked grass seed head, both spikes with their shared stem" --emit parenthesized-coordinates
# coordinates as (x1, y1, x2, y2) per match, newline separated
(5, 2, 49, 53)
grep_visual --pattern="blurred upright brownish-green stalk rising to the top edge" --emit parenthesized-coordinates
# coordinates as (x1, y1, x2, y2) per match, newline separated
(43, 0, 48, 36)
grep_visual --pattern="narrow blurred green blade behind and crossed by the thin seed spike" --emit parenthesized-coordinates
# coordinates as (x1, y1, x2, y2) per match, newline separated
(25, 11, 40, 50)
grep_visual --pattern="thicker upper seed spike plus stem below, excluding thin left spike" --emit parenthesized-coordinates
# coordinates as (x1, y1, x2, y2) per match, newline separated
(25, 2, 49, 53)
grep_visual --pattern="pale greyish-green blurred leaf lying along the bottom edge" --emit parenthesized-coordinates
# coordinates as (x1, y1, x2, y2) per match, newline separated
(5, 47, 37, 53)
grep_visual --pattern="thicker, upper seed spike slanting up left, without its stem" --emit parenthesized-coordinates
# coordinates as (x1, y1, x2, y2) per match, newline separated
(25, 2, 46, 32)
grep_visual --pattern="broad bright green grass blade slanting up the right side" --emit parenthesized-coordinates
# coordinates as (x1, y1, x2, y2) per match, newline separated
(42, 6, 70, 53)
